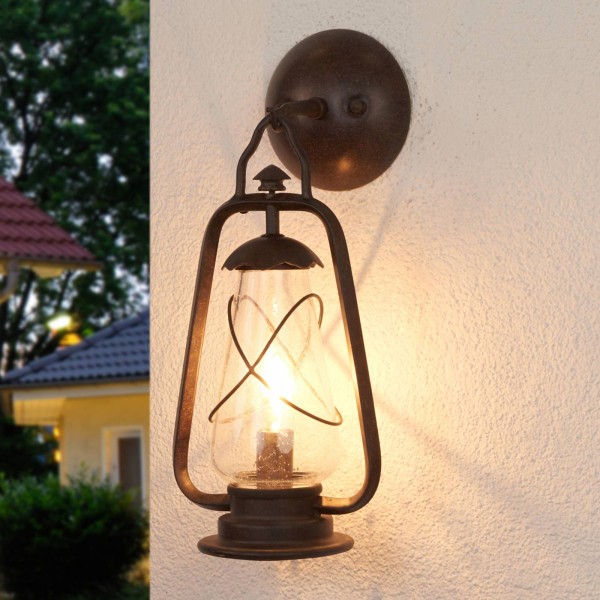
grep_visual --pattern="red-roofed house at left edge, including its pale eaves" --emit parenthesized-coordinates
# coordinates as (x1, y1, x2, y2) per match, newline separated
(0, 177, 101, 304)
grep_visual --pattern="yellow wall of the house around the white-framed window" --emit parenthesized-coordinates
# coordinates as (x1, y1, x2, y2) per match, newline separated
(60, 394, 150, 498)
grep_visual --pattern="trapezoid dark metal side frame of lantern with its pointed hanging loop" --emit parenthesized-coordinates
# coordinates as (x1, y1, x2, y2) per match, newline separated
(173, 110, 381, 514)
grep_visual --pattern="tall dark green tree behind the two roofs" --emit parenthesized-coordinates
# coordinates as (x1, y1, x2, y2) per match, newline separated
(0, 0, 149, 371)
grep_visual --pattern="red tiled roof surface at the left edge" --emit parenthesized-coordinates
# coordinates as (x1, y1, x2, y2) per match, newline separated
(0, 177, 98, 268)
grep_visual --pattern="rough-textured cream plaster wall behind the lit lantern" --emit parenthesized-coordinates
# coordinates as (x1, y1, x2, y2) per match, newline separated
(151, 0, 600, 600)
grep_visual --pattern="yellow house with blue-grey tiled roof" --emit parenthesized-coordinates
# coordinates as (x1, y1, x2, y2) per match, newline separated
(0, 310, 149, 505)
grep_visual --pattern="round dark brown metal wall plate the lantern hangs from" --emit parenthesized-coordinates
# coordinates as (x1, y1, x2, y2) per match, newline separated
(266, 29, 411, 191)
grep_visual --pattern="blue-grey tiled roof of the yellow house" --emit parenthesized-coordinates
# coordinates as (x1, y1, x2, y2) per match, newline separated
(0, 310, 150, 389)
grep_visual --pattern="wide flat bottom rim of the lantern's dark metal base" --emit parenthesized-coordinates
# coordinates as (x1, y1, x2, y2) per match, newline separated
(198, 533, 354, 560)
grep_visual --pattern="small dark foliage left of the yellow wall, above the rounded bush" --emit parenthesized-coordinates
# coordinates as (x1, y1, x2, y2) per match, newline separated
(0, 414, 56, 479)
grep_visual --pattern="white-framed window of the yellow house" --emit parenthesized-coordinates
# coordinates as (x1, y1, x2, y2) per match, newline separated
(102, 427, 145, 506)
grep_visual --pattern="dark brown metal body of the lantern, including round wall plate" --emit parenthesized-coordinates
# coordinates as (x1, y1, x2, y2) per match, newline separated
(173, 29, 411, 560)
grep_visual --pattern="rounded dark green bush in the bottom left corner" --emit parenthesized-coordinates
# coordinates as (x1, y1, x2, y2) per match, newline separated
(0, 475, 148, 600)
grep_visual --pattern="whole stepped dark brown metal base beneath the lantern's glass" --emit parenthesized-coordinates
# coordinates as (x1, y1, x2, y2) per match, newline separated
(198, 485, 354, 560)
